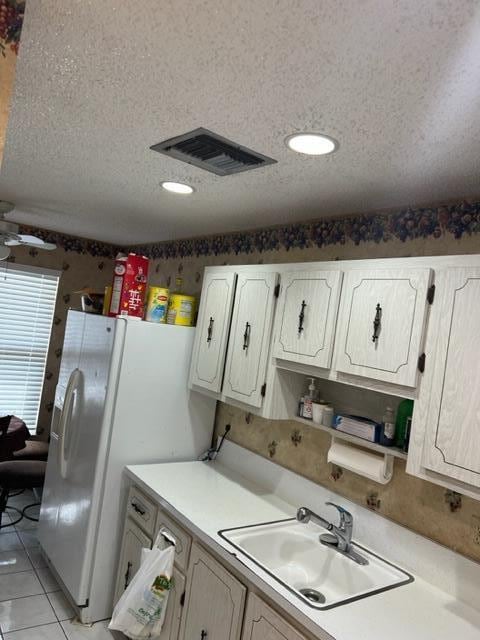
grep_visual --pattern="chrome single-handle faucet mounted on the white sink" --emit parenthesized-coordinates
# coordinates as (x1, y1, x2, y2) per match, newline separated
(297, 502, 368, 565)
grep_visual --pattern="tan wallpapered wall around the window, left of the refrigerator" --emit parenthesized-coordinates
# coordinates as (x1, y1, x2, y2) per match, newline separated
(5, 247, 113, 436)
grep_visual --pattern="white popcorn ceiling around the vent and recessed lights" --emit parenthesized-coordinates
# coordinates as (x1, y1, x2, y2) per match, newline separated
(0, 0, 480, 243)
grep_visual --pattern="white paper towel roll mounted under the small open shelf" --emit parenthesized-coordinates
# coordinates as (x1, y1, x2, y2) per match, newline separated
(327, 438, 393, 484)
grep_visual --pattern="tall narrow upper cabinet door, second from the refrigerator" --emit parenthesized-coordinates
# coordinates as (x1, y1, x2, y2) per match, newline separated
(223, 272, 277, 407)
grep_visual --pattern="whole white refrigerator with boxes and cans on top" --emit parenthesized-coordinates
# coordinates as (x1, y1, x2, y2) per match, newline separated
(38, 311, 215, 623)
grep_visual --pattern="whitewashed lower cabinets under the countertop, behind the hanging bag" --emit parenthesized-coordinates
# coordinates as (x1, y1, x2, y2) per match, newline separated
(115, 485, 316, 640)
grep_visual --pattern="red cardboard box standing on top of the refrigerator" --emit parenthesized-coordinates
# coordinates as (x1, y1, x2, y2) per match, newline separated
(108, 253, 148, 318)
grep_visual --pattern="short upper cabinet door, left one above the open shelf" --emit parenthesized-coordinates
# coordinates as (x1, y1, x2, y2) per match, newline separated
(273, 271, 342, 368)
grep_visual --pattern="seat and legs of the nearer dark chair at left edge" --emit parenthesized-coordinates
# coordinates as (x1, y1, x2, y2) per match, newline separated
(0, 460, 47, 529)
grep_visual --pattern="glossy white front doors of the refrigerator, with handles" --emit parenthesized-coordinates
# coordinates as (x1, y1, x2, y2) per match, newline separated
(38, 314, 116, 606)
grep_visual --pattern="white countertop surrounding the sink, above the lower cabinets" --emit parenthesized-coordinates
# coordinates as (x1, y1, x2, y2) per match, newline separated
(127, 443, 480, 640)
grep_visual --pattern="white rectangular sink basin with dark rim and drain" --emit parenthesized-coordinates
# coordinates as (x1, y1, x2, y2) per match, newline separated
(218, 520, 413, 609)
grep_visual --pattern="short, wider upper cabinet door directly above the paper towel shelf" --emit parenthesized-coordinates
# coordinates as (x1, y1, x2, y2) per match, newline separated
(336, 269, 432, 387)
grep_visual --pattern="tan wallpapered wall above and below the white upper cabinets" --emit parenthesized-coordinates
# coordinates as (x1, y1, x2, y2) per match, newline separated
(150, 234, 480, 561)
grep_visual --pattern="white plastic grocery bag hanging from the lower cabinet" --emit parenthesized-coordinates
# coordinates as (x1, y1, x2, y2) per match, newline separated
(108, 531, 175, 640)
